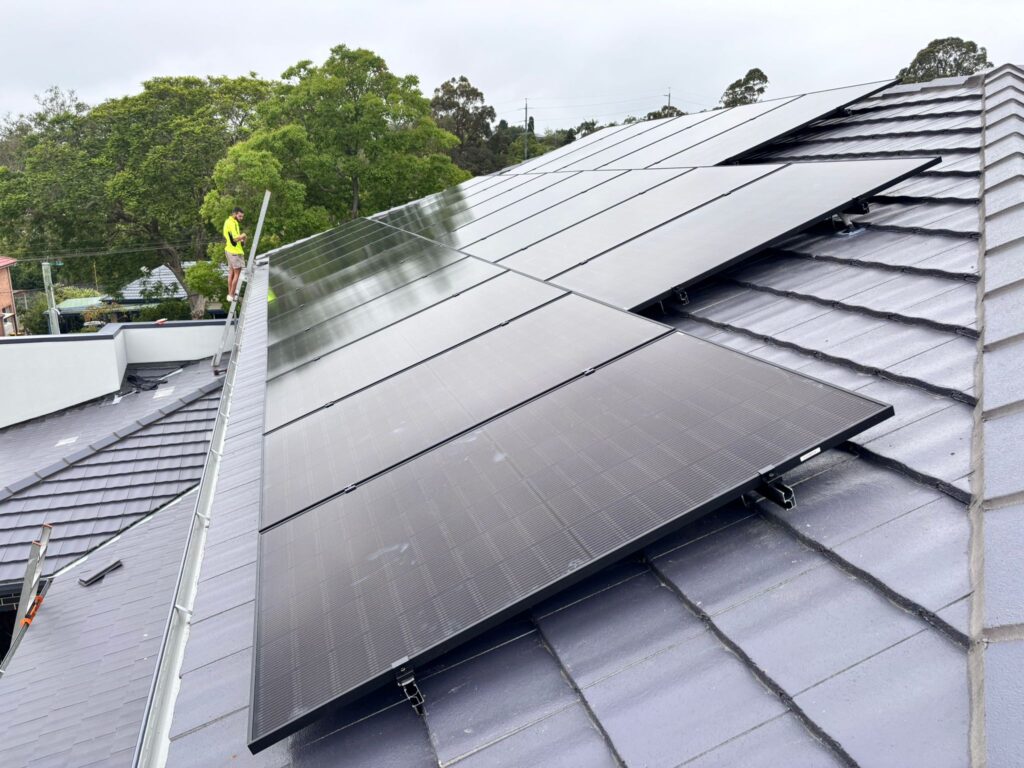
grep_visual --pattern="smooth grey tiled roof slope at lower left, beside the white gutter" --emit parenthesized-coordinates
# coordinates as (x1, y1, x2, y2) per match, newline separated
(0, 493, 196, 766)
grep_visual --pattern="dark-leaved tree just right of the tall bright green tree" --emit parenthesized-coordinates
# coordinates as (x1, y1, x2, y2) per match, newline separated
(430, 75, 501, 175)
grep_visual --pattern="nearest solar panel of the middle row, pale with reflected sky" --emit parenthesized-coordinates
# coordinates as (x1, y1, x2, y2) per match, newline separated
(552, 158, 938, 308)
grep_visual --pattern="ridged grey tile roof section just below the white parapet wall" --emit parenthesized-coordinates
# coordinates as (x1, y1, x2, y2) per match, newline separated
(0, 360, 221, 583)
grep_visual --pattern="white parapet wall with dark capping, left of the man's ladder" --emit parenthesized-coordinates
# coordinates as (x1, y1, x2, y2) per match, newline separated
(0, 321, 233, 427)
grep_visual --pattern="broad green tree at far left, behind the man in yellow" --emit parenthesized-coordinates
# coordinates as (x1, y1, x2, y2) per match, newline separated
(0, 77, 269, 316)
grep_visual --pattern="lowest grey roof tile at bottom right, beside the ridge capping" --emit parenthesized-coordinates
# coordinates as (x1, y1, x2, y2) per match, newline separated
(796, 630, 969, 768)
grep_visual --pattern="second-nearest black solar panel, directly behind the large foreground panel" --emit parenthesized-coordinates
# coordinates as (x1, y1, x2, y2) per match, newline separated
(261, 296, 667, 527)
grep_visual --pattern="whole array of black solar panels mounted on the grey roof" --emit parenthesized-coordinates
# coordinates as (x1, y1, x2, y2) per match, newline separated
(243, 78, 927, 751)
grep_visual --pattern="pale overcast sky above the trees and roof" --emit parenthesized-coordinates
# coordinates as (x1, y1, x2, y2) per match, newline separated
(6, 0, 1024, 128)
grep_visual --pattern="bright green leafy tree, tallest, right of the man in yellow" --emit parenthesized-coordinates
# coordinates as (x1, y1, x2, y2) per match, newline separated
(232, 45, 470, 225)
